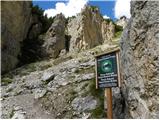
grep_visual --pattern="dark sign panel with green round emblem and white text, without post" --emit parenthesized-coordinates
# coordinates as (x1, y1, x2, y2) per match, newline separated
(96, 52, 118, 88)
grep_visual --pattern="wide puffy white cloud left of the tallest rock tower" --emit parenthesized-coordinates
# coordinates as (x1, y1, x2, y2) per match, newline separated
(44, 0, 88, 17)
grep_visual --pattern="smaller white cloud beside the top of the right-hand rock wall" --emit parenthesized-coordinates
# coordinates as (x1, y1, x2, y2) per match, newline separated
(114, 0, 131, 18)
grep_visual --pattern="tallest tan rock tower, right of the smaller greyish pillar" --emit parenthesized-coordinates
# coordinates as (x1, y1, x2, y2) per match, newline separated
(67, 6, 114, 51)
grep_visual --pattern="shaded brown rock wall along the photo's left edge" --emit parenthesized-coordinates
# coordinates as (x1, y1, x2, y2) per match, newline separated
(1, 1, 31, 73)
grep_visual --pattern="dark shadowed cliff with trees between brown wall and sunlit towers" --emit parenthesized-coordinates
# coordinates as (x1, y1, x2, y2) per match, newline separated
(18, 5, 53, 66)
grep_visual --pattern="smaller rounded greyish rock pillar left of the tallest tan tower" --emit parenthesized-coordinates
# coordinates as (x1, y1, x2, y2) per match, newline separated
(43, 14, 65, 58)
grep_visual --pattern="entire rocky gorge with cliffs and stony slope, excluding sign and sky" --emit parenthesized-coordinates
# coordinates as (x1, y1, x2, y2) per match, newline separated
(1, 1, 159, 119)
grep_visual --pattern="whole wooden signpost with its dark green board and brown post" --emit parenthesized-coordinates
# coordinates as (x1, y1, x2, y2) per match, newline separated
(96, 49, 120, 119)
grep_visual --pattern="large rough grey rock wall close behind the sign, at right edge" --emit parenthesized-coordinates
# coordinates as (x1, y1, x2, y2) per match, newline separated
(121, 1, 159, 119)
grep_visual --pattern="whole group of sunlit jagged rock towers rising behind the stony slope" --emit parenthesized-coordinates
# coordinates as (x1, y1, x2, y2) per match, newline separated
(43, 6, 115, 58)
